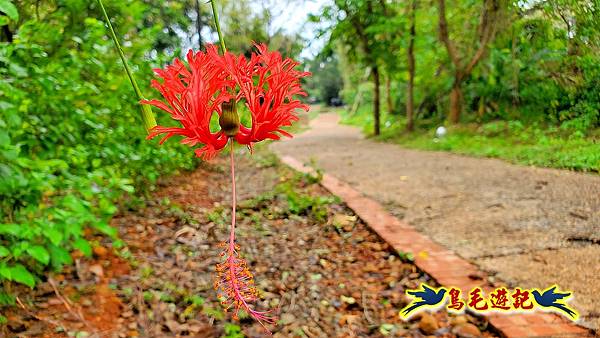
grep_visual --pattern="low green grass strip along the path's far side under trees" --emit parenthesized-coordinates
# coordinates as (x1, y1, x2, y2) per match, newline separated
(342, 109, 600, 172)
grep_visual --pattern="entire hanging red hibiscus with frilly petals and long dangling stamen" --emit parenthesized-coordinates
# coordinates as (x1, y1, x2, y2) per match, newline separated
(142, 45, 308, 332)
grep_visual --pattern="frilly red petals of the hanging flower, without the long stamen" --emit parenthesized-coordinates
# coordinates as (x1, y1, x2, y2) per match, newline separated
(142, 45, 309, 160)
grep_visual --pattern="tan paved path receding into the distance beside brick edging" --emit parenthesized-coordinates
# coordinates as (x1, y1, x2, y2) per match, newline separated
(272, 113, 600, 328)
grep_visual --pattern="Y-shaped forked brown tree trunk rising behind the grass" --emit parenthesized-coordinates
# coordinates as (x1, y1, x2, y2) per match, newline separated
(437, 0, 503, 123)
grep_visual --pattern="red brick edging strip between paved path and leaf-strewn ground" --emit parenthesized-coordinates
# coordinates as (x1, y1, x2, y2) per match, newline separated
(281, 156, 592, 338)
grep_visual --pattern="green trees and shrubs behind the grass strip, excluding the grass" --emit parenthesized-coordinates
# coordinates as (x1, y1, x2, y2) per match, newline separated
(315, 0, 600, 145)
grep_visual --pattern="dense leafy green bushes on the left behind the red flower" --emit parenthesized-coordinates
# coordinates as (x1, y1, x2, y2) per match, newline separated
(0, 1, 202, 287)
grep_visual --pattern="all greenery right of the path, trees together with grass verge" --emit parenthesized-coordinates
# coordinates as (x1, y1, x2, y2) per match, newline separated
(308, 0, 600, 172)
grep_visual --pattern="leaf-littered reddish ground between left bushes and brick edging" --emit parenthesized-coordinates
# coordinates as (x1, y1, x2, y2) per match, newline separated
(2, 151, 494, 337)
